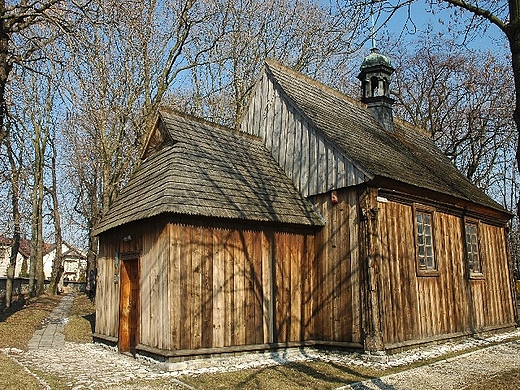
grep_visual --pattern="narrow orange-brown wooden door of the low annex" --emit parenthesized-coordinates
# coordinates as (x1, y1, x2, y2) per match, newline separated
(119, 259, 139, 354)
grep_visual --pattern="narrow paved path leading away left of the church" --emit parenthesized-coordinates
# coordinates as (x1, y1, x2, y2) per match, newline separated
(28, 294, 74, 351)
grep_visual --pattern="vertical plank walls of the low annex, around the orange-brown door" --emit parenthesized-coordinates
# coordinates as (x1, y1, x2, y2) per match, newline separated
(96, 220, 334, 350)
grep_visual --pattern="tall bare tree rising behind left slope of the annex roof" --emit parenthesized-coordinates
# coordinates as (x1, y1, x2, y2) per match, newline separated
(64, 0, 225, 272)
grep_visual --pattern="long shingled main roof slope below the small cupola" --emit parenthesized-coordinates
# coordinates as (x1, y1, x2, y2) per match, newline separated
(265, 60, 507, 213)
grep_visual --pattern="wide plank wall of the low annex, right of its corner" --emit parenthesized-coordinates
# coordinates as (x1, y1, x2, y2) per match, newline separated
(168, 224, 312, 349)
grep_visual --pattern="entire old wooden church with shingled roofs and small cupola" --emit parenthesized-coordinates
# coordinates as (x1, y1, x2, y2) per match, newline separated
(94, 50, 515, 361)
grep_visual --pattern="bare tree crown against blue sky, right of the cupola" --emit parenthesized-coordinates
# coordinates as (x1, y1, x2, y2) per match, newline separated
(392, 35, 516, 193)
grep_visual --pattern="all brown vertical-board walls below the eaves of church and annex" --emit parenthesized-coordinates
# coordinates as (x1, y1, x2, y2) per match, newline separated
(96, 210, 514, 356)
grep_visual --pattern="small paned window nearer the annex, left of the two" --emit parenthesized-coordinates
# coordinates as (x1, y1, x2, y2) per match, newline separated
(414, 209, 438, 276)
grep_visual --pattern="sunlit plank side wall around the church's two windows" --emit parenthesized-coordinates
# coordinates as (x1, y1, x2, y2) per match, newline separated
(378, 202, 514, 345)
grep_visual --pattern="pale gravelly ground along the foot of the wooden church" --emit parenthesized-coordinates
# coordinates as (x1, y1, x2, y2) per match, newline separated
(3, 329, 520, 390)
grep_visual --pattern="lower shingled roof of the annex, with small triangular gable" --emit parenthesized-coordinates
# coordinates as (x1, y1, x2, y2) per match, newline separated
(94, 111, 324, 235)
